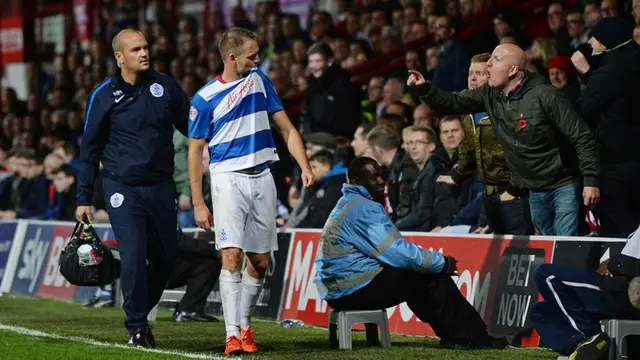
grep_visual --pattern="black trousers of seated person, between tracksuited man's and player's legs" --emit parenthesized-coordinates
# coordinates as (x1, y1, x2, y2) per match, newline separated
(167, 256, 222, 314)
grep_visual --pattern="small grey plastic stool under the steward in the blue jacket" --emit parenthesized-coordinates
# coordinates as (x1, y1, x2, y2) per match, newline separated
(329, 310, 391, 350)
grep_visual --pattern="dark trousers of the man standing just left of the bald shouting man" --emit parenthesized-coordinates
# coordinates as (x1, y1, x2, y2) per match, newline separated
(484, 194, 534, 235)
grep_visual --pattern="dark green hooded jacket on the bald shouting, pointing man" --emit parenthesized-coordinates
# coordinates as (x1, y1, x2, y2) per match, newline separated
(420, 72, 600, 191)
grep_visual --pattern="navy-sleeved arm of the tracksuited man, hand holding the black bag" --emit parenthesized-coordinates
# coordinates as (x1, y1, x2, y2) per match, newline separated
(76, 83, 110, 221)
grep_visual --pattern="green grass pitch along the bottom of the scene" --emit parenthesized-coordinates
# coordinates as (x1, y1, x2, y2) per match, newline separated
(0, 295, 557, 360)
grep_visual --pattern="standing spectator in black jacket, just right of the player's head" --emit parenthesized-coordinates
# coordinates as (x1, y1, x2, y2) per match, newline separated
(302, 43, 362, 137)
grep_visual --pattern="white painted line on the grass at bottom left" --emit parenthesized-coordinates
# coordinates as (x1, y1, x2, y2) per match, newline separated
(0, 324, 226, 360)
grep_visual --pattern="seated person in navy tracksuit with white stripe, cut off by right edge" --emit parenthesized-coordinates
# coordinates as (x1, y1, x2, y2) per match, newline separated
(531, 224, 640, 360)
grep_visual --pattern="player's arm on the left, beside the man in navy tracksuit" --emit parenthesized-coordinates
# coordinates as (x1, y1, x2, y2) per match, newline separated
(188, 94, 213, 230)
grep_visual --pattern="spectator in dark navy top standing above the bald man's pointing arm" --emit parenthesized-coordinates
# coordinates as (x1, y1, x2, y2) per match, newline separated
(433, 16, 469, 91)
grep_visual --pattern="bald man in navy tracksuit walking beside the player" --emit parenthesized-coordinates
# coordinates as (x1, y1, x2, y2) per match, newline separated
(76, 29, 189, 348)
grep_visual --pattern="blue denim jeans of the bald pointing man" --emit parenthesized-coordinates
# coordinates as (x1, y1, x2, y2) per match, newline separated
(529, 183, 581, 236)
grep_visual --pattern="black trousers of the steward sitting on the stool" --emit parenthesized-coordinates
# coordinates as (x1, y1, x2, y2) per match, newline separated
(327, 267, 489, 344)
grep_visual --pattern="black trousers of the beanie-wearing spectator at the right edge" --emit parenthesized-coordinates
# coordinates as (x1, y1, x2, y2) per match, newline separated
(598, 162, 640, 238)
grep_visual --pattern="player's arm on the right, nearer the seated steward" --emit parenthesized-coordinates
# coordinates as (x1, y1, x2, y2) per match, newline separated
(258, 70, 315, 187)
